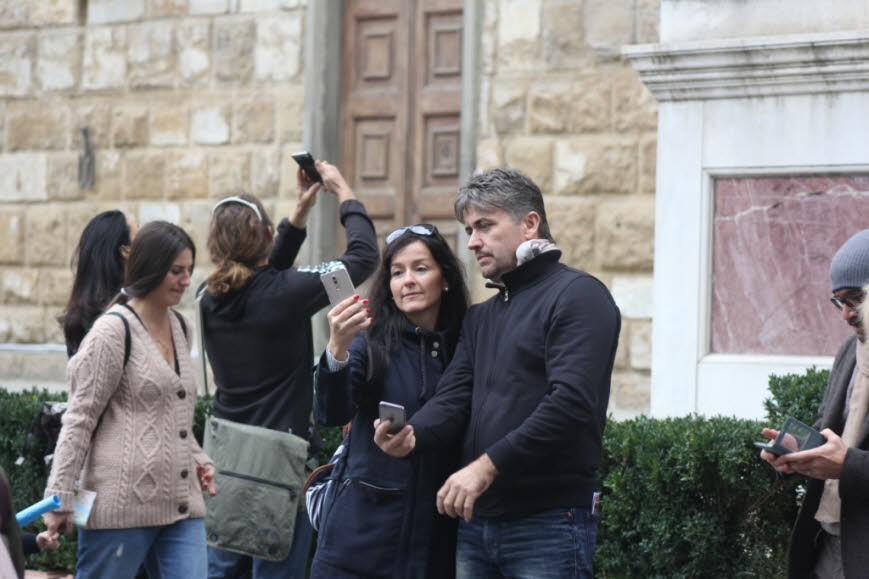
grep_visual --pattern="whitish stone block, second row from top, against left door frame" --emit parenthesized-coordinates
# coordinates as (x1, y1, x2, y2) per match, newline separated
(255, 12, 303, 82)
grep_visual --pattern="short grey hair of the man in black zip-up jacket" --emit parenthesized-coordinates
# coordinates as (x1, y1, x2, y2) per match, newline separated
(453, 167, 555, 242)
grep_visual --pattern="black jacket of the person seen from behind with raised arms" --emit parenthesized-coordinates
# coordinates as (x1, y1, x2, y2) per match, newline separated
(202, 200, 378, 438)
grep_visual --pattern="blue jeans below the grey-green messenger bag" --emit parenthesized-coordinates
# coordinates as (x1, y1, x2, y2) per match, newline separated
(208, 510, 314, 579)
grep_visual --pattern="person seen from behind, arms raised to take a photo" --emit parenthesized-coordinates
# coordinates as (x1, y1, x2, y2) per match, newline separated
(201, 161, 377, 579)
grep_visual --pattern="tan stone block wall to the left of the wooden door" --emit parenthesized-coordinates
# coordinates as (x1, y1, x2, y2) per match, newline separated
(0, 0, 305, 390)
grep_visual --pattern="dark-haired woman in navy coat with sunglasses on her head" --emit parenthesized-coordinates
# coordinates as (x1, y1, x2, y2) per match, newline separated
(311, 224, 468, 578)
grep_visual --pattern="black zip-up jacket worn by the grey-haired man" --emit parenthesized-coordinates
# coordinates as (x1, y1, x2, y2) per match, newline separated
(410, 250, 621, 520)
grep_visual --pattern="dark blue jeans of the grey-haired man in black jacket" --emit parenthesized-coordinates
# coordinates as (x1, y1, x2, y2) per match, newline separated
(456, 508, 598, 579)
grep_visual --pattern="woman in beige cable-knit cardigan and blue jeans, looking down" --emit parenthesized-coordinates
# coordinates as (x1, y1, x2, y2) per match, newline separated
(44, 222, 216, 579)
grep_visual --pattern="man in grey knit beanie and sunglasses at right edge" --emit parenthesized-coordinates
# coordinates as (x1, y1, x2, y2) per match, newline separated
(761, 229, 869, 579)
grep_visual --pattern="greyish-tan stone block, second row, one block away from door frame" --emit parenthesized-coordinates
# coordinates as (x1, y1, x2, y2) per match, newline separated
(214, 19, 256, 84)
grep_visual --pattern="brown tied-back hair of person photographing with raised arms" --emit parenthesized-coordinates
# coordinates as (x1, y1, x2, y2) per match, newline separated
(206, 193, 272, 294)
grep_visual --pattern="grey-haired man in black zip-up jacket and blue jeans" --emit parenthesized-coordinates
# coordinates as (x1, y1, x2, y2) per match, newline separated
(375, 169, 621, 578)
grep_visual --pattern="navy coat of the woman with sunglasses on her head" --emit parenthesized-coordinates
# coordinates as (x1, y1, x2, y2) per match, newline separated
(311, 325, 458, 579)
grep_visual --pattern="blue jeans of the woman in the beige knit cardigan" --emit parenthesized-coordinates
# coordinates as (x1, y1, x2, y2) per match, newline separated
(75, 519, 208, 579)
